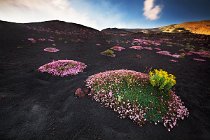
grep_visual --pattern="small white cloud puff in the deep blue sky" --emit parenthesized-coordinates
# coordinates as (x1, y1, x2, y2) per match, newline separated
(143, 0, 162, 20)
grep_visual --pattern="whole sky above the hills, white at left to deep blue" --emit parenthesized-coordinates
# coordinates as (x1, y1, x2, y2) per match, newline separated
(0, 0, 210, 30)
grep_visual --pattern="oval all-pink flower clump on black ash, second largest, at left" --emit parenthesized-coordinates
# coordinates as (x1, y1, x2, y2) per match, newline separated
(38, 60, 87, 77)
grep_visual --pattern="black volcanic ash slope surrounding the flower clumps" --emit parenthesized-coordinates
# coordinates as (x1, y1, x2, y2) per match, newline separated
(0, 21, 210, 140)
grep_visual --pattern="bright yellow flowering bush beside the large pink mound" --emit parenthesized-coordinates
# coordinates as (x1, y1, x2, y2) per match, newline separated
(149, 69, 176, 91)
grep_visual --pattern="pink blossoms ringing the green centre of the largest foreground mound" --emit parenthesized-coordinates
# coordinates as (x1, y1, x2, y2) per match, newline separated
(86, 69, 189, 131)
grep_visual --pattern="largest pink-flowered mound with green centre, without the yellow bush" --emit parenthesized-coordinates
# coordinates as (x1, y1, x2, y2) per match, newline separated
(86, 69, 189, 131)
